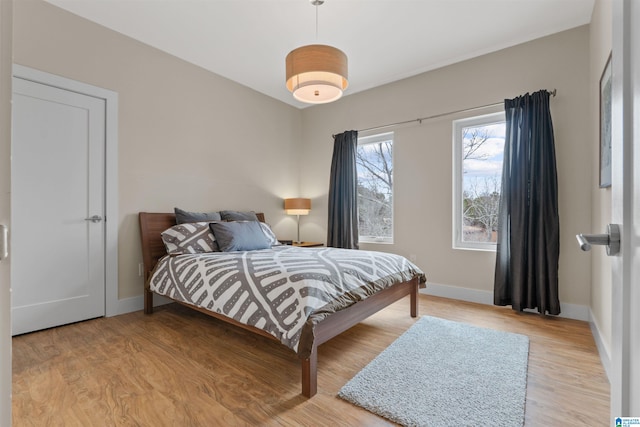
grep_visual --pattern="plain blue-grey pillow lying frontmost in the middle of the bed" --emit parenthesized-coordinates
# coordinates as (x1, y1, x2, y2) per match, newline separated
(209, 221, 271, 252)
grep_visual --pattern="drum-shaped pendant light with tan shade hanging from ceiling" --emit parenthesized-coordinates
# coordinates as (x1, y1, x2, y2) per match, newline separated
(285, 0, 349, 104)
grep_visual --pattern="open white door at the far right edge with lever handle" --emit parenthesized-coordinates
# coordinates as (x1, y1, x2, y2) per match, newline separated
(610, 0, 640, 420)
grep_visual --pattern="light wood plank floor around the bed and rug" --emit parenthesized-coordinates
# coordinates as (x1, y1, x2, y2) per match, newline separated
(13, 295, 610, 427)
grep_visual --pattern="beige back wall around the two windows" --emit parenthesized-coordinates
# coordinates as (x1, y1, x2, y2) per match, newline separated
(301, 26, 594, 318)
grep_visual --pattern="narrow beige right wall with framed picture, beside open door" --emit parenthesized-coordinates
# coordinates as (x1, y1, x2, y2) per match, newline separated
(588, 0, 612, 362)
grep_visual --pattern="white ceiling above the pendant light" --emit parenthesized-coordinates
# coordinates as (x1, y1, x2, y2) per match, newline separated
(47, 0, 594, 108)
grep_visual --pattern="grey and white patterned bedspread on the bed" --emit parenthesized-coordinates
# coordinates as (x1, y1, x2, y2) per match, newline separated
(150, 246, 426, 358)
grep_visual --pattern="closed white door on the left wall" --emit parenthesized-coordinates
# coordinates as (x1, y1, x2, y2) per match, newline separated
(11, 77, 105, 335)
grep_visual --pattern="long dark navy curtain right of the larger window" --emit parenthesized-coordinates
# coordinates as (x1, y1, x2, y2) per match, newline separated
(494, 90, 560, 314)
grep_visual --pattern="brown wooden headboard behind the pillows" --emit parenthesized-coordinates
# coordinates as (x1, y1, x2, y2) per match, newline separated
(138, 212, 265, 284)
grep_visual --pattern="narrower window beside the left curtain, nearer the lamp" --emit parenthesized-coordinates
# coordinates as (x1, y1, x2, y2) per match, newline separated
(356, 132, 393, 243)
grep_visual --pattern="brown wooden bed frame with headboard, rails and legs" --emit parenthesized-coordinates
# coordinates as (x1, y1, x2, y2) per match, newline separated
(139, 212, 419, 397)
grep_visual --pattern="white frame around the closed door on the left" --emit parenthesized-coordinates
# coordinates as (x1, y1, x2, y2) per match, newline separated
(13, 64, 122, 317)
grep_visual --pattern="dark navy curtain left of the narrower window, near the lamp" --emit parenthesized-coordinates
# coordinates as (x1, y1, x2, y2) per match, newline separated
(327, 130, 358, 249)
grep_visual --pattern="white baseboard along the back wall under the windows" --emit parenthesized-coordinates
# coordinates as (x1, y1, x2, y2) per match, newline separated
(420, 282, 590, 322)
